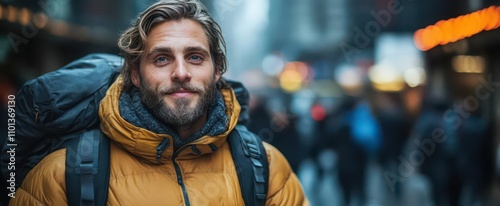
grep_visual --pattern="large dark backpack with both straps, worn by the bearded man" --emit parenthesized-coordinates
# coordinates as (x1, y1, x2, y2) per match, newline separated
(0, 54, 269, 205)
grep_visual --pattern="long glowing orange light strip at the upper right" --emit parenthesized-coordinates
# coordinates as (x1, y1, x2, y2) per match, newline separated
(413, 6, 500, 51)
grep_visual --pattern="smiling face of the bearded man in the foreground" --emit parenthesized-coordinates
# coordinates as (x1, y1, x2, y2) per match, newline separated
(132, 19, 220, 126)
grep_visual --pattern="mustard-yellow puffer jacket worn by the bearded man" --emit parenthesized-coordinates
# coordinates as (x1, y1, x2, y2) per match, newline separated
(10, 78, 309, 206)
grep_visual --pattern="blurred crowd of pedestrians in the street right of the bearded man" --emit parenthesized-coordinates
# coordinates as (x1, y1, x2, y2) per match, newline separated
(243, 63, 495, 205)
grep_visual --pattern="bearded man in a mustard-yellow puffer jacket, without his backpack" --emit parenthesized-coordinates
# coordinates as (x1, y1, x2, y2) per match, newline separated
(11, 0, 308, 205)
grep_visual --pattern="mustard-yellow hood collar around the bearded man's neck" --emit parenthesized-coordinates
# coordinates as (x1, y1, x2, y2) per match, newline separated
(99, 76, 241, 164)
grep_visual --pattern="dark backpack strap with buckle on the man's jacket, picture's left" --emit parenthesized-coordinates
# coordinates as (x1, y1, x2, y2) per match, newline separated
(66, 129, 109, 206)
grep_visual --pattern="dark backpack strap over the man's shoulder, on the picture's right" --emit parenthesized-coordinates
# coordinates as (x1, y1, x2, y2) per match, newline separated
(228, 125, 269, 205)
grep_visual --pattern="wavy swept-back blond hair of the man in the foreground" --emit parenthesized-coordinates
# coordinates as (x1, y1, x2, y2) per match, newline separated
(118, 0, 227, 91)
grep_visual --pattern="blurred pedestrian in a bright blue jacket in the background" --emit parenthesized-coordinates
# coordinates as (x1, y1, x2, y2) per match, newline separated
(326, 96, 372, 205)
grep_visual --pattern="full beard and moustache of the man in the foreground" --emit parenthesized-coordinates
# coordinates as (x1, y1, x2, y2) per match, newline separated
(139, 75, 216, 127)
